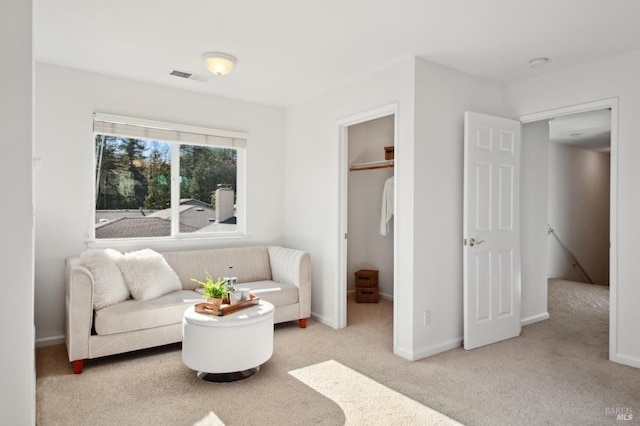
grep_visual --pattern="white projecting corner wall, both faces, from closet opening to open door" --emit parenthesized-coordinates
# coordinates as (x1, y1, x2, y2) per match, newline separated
(285, 59, 509, 359)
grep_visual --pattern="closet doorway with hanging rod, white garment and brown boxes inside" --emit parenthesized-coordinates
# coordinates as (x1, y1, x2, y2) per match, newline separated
(336, 104, 397, 328)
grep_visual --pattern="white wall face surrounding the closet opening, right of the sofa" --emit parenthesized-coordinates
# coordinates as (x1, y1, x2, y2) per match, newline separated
(284, 59, 415, 357)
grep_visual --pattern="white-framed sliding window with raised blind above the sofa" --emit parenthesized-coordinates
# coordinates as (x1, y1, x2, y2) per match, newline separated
(93, 114, 246, 241)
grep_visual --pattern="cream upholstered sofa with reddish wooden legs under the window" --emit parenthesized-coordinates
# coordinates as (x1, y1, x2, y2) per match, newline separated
(65, 247, 311, 374)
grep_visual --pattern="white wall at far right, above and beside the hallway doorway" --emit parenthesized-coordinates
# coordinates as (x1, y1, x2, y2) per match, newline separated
(507, 52, 640, 367)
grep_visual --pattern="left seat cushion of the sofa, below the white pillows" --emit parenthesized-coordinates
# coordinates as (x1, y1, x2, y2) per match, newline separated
(94, 290, 203, 336)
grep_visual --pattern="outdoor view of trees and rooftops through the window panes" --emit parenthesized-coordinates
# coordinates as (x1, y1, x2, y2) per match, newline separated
(95, 133, 238, 239)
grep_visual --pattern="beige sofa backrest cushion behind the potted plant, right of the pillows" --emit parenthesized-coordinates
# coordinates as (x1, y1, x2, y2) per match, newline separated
(162, 247, 272, 290)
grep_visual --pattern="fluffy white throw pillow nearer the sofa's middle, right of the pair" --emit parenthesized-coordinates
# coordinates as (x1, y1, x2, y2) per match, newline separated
(117, 249, 182, 300)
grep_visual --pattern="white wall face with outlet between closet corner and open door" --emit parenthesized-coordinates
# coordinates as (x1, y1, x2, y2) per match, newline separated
(412, 59, 512, 358)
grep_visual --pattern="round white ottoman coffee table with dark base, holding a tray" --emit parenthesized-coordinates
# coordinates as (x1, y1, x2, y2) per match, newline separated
(182, 300, 274, 382)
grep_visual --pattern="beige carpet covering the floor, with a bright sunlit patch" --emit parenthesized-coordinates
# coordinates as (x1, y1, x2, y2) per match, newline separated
(36, 281, 640, 426)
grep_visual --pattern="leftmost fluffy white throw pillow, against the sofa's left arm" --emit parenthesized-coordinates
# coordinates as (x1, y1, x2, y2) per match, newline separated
(80, 249, 130, 310)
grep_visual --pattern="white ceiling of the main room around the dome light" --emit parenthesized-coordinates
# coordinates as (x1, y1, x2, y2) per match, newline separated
(34, 0, 640, 107)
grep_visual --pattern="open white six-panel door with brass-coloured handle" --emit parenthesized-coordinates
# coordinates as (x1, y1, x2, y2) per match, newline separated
(463, 112, 521, 349)
